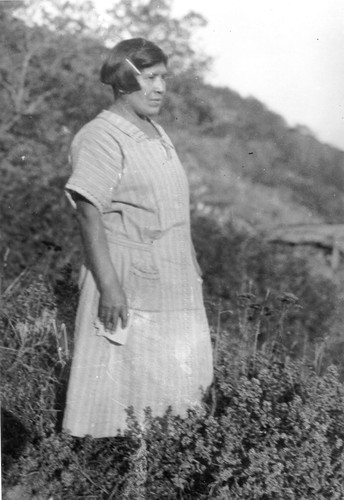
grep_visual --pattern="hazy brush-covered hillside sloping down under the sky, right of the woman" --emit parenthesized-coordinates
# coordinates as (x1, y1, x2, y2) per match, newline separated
(160, 78, 344, 227)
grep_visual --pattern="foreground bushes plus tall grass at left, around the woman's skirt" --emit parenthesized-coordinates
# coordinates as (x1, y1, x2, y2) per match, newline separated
(1, 275, 344, 500)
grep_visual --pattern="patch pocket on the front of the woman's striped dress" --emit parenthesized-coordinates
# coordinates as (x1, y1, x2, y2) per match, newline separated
(126, 252, 161, 311)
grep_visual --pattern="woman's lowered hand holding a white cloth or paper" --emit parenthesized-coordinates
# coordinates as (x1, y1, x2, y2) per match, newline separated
(98, 285, 128, 331)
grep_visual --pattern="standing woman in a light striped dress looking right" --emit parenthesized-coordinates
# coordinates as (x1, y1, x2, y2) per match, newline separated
(63, 38, 212, 437)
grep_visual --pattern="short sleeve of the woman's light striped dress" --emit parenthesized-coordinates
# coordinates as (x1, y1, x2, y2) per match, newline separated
(65, 127, 123, 212)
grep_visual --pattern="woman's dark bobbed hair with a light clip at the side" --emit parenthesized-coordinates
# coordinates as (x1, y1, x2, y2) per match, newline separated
(100, 38, 168, 98)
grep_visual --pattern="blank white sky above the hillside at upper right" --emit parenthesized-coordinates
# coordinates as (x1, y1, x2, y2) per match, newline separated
(94, 0, 344, 150)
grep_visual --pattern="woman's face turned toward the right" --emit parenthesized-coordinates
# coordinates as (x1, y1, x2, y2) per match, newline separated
(123, 63, 167, 116)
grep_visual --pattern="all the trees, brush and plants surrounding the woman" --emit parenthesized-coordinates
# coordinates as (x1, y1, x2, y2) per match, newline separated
(0, 0, 344, 500)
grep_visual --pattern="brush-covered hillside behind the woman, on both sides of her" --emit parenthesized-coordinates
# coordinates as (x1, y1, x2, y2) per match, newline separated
(0, 8, 344, 279)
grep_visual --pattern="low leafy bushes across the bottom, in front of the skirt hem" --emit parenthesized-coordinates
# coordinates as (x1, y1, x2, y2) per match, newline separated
(5, 356, 344, 500)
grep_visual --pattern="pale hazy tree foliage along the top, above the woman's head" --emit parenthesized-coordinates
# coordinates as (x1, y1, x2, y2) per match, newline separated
(11, 0, 210, 73)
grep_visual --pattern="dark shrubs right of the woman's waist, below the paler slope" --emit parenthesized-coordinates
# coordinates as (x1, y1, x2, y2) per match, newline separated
(193, 217, 341, 364)
